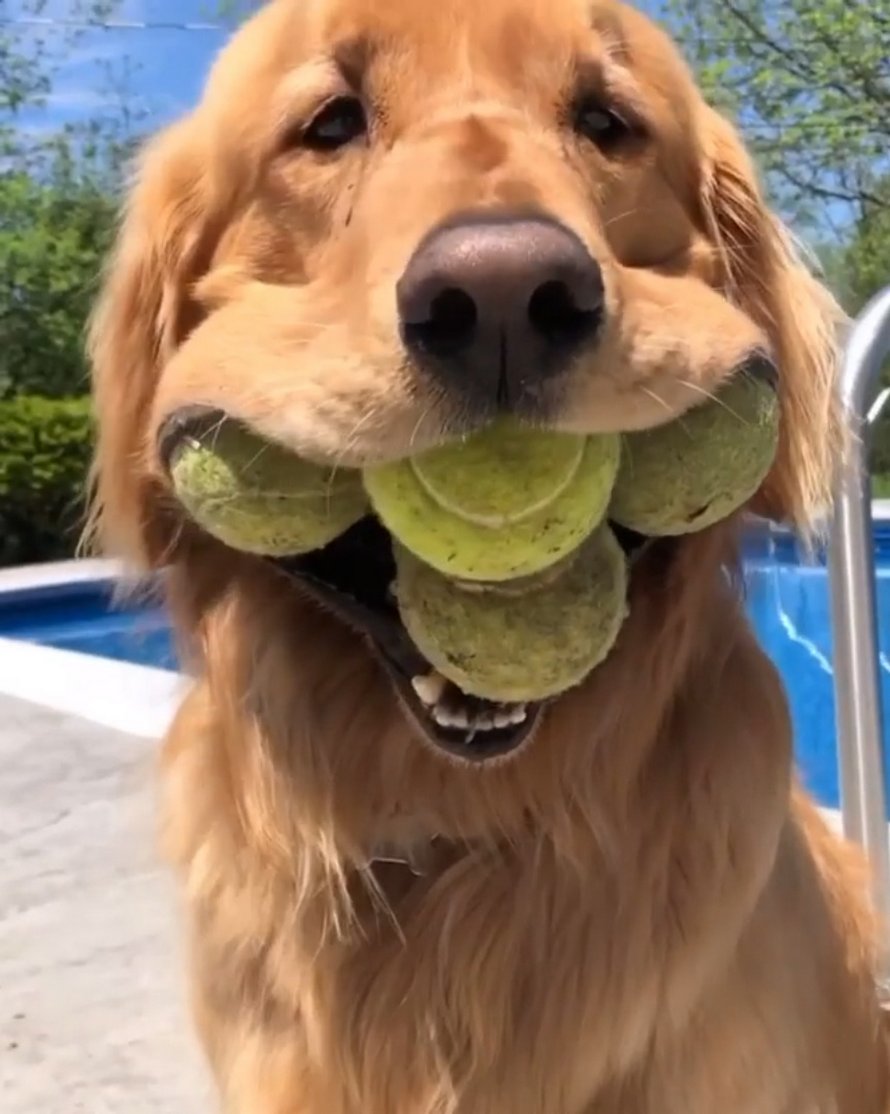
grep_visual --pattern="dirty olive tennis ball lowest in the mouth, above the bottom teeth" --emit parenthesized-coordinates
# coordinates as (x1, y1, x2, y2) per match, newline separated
(395, 526, 627, 702)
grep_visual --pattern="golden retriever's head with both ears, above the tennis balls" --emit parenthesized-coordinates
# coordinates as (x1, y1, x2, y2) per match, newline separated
(92, 0, 835, 766)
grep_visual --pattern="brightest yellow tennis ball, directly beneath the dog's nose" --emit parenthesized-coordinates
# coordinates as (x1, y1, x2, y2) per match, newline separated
(364, 420, 618, 580)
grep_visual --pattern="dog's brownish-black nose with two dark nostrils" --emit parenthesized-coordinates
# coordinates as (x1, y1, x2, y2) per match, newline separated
(397, 218, 604, 409)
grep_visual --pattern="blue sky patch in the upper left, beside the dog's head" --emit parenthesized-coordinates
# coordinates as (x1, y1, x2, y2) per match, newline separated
(0, 0, 658, 139)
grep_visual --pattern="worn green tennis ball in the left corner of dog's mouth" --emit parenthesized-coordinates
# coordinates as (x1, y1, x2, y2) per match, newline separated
(170, 421, 368, 557)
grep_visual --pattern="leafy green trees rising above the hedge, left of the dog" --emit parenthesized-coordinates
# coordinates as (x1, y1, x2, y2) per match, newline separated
(0, 0, 135, 398)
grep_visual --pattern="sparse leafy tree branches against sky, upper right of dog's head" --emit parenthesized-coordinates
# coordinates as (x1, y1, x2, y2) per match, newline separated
(667, 0, 890, 234)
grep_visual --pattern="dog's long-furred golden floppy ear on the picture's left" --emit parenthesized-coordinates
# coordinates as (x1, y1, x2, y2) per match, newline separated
(88, 119, 217, 568)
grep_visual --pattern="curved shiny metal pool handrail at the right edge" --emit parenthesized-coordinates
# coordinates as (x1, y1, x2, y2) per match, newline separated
(829, 287, 890, 984)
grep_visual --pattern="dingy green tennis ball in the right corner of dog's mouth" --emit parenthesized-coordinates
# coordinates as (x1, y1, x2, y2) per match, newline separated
(609, 374, 779, 537)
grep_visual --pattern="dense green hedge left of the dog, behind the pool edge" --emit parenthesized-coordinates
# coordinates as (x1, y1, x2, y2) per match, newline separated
(0, 394, 92, 565)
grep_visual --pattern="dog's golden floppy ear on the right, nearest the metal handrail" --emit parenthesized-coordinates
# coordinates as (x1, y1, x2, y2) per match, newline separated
(702, 109, 844, 535)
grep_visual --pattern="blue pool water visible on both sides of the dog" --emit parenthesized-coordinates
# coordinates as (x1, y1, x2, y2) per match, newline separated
(0, 522, 890, 808)
